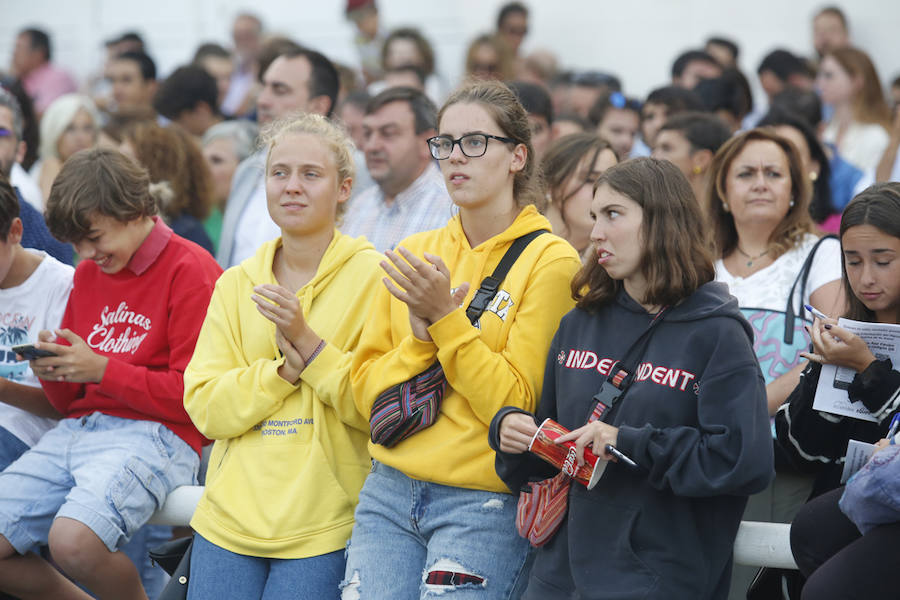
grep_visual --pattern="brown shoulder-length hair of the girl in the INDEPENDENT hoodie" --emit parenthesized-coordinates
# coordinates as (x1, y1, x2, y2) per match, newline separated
(572, 157, 716, 311)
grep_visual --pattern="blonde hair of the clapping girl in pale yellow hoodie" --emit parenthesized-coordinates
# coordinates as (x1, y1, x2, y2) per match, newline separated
(260, 114, 356, 217)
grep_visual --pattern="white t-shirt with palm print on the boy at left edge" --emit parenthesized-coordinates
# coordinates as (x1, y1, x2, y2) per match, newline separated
(0, 248, 75, 446)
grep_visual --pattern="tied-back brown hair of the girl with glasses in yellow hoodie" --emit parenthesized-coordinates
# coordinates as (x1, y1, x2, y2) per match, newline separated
(437, 81, 544, 210)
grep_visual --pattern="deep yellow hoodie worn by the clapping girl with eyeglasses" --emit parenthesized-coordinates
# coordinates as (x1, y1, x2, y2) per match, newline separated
(351, 206, 580, 493)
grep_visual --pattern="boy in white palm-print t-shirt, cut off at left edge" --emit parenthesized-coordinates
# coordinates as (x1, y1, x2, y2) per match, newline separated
(0, 174, 75, 471)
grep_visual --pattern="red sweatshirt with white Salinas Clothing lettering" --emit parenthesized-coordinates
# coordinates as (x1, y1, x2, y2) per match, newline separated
(41, 217, 222, 452)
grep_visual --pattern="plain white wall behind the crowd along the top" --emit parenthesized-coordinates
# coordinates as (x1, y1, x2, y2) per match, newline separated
(0, 0, 900, 106)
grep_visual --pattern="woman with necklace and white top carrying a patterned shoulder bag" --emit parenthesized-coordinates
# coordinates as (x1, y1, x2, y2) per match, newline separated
(707, 128, 844, 597)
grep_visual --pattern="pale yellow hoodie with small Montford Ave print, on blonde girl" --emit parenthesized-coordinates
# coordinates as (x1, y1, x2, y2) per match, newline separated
(184, 231, 383, 558)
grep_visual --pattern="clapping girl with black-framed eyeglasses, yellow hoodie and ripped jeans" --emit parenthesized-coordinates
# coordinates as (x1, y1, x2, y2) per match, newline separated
(342, 82, 579, 600)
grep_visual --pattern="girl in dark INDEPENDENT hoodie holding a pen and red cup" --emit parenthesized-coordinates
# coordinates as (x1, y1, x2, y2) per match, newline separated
(491, 158, 773, 600)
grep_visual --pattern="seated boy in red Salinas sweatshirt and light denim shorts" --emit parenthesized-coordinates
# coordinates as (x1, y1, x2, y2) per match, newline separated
(0, 149, 221, 600)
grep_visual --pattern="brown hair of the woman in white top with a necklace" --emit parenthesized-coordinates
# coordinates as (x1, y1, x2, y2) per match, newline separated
(706, 127, 815, 258)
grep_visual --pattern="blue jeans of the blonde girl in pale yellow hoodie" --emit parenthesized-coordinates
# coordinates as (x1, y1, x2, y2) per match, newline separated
(188, 534, 344, 600)
